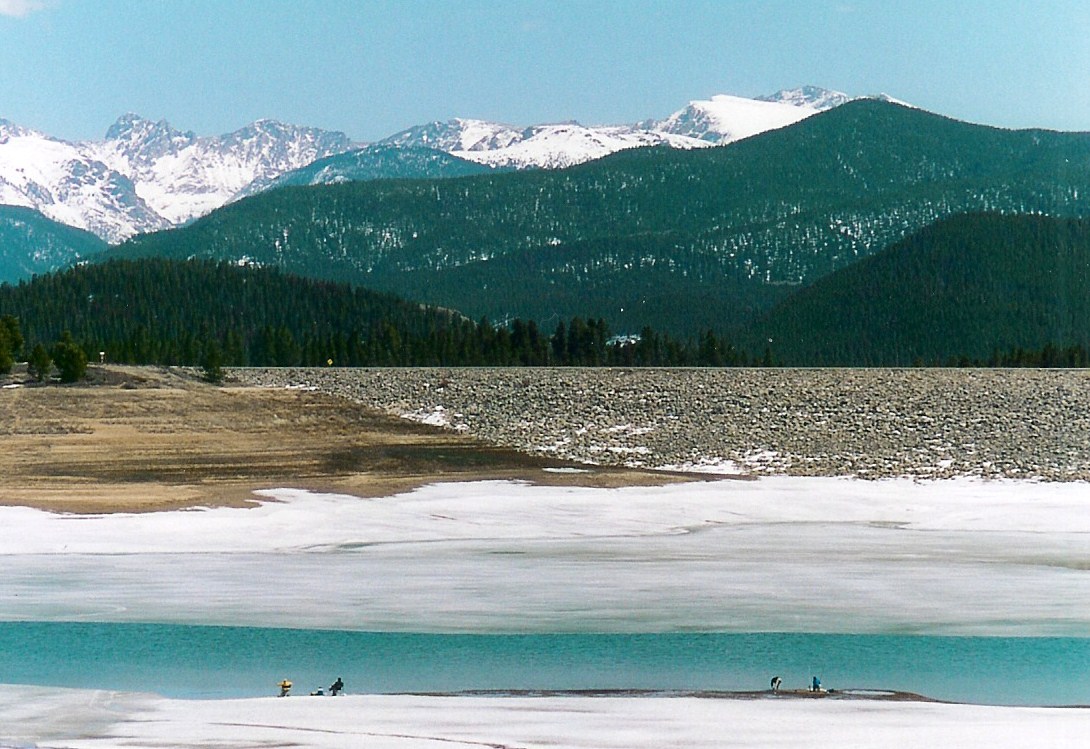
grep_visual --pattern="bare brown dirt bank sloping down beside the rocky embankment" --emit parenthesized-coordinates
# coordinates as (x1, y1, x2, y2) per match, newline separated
(0, 366, 679, 512)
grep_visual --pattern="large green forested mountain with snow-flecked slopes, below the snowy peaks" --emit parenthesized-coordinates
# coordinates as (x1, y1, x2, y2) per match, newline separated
(106, 100, 1090, 336)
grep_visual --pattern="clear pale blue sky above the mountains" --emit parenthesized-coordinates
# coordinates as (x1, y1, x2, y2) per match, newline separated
(0, 0, 1090, 141)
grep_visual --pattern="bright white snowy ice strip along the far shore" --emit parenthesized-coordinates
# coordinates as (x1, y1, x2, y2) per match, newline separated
(0, 478, 1090, 554)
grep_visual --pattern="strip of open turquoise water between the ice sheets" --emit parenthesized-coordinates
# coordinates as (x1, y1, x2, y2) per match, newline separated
(0, 621, 1090, 704)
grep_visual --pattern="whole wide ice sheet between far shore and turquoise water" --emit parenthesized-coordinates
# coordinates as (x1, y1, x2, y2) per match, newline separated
(0, 479, 1090, 637)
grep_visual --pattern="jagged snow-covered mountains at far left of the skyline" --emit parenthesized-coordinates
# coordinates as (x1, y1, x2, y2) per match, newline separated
(0, 114, 352, 242)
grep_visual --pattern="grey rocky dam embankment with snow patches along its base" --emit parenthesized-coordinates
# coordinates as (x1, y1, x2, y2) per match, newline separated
(230, 369, 1090, 481)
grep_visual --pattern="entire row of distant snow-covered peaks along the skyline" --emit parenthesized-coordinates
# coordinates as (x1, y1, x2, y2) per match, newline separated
(0, 86, 863, 243)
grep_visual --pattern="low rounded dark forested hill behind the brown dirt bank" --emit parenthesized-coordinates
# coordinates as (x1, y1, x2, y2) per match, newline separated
(0, 259, 474, 364)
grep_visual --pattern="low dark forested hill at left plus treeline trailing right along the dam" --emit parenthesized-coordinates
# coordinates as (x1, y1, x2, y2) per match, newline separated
(0, 258, 750, 366)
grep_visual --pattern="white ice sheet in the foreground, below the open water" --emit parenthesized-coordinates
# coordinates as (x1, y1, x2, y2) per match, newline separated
(0, 687, 1090, 749)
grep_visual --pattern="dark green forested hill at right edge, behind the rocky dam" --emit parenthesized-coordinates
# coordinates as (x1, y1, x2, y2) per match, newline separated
(752, 215, 1090, 366)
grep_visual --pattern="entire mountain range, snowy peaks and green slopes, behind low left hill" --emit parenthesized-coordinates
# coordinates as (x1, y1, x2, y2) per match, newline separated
(0, 88, 1090, 364)
